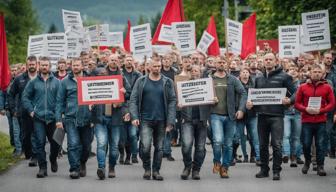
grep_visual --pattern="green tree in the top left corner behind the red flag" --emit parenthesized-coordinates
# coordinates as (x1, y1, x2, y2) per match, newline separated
(0, 0, 41, 63)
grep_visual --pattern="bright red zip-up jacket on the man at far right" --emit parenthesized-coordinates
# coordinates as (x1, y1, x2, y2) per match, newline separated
(295, 80, 335, 123)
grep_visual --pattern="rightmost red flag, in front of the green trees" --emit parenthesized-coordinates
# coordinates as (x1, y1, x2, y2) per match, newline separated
(240, 13, 257, 59)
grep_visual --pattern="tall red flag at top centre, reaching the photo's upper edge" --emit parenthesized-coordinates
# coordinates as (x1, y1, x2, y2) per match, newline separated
(152, 0, 185, 45)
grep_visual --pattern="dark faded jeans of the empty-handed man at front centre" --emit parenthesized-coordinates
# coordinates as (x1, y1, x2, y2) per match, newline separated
(140, 121, 166, 172)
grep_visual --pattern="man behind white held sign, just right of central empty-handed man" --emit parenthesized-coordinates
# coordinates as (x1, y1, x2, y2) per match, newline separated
(181, 66, 209, 180)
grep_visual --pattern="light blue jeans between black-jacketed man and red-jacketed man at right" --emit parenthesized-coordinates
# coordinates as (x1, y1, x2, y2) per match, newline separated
(282, 113, 301, 157)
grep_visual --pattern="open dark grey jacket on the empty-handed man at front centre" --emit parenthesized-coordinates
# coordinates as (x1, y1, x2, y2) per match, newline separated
(129, 75, 176, 125)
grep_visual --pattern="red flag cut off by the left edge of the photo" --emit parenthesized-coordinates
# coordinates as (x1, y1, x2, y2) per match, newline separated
(0, 13, 11, 91)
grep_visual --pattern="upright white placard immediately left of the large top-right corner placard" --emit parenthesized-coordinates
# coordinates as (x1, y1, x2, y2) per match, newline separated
(278, 25, 300, 58)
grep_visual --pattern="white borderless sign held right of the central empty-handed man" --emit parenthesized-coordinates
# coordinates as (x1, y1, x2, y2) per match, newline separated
(176, 78, 215, 106)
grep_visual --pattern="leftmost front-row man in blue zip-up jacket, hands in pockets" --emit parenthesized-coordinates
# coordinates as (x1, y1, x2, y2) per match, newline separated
(22, 57, 60, 178)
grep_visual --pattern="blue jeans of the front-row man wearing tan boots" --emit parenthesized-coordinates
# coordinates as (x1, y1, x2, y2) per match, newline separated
(210, 114, 235, 168)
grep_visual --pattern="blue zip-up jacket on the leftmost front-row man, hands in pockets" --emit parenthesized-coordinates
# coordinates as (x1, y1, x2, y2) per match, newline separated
(22, 73, 60, 123)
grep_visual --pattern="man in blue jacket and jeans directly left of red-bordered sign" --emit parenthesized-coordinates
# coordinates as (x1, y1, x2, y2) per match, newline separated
(56, 58, 93, 179)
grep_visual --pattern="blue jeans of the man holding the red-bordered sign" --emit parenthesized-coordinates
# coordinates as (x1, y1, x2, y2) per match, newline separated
(95, 117, 123, 168)
